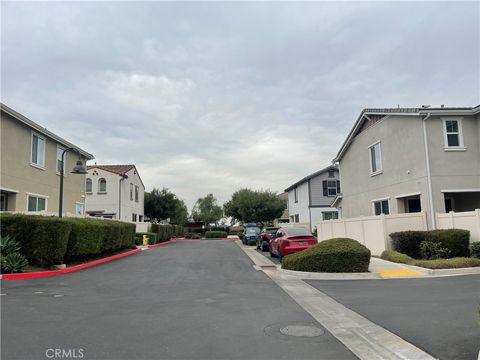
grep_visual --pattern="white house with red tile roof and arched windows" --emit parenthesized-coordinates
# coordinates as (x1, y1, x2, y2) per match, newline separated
(85, 164, 145, 223)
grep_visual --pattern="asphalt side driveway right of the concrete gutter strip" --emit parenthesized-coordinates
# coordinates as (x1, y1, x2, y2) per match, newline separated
(307, 275, 480, 360)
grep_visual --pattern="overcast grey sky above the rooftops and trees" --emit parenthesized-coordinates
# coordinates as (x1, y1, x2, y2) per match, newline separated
(1, 2, 480, 208)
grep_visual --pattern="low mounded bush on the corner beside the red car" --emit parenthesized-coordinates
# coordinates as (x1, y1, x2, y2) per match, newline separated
(282, 238, 370, 273)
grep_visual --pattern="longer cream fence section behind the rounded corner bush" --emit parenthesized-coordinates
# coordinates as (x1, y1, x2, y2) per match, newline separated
(317, 212, 427, 256)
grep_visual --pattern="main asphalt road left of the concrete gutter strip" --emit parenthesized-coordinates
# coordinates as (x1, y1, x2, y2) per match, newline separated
(1, 241, 356, 360)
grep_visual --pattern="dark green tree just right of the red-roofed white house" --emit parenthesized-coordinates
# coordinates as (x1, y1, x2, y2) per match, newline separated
(145, 188, 188, 225)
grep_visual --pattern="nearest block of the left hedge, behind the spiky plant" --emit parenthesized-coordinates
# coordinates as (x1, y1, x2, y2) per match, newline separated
(0, 214, 71, 266)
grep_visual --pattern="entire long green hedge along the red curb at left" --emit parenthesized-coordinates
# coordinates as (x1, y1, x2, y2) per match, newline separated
(0, 214, 135, 266)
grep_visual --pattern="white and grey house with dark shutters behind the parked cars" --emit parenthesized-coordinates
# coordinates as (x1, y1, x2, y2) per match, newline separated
(285, 165, 340, 230)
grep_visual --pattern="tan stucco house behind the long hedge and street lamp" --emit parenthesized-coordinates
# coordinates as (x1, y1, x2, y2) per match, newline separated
(0, 104, 94, 216)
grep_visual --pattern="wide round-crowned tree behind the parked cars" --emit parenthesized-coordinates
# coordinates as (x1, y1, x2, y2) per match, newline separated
(223, 189, 287, 223)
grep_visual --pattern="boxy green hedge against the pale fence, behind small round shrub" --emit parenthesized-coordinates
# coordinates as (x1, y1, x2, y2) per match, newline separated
(390, 229, 470, 259)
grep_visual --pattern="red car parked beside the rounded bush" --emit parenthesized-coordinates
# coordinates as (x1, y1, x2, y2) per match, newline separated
(270, 228, 317, 259)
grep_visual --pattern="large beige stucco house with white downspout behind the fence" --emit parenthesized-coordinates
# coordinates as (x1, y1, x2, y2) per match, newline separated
(332, 105, 480, 228)
